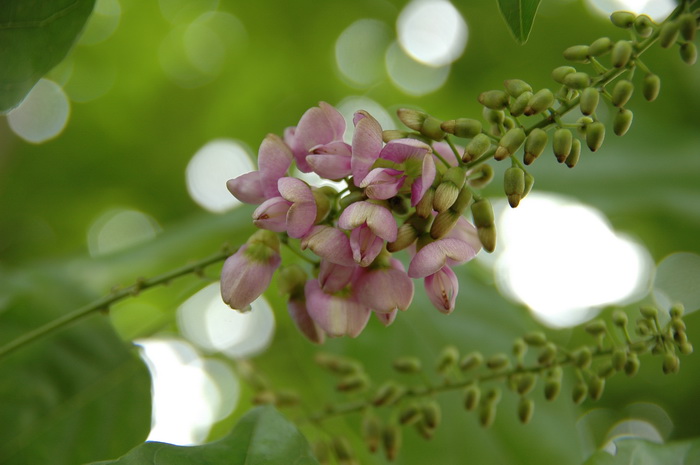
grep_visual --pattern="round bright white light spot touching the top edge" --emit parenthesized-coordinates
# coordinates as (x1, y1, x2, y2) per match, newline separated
(396, 0, 468, 67)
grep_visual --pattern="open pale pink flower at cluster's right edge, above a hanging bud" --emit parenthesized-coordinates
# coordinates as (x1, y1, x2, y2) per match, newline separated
(408, 217, 481, 278)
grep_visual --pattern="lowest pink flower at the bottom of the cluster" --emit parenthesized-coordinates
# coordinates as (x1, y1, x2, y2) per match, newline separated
(304, 279, 371, 337)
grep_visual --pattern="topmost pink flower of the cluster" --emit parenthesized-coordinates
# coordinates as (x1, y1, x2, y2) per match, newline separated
(284, 102, 345, 173)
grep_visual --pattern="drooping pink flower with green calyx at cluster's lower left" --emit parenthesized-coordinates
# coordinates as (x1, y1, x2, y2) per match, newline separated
(221, 230, 281, 311)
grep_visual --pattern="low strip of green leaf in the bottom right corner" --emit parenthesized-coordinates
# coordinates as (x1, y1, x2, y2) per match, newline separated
(584, 438, 700, 465)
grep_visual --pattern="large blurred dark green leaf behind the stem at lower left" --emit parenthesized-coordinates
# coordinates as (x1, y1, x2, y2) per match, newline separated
(0, 270, 151, 465)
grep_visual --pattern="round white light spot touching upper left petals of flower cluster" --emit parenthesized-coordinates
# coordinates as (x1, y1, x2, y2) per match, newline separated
(185, 139, 256, 213)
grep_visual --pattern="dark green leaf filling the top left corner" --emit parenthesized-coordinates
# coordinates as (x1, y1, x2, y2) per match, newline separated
(0, 0, 95, 112)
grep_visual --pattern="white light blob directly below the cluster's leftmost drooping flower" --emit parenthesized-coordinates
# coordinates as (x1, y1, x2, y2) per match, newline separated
(177, 282, 275, 358)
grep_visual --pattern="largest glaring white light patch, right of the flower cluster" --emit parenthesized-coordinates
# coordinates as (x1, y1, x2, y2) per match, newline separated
(487, 193, 652, 328)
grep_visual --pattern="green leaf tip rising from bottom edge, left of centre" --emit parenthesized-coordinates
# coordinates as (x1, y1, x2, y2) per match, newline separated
(85, 406, 318, 465)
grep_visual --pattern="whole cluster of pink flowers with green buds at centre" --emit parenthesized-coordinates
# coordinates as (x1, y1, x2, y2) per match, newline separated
(221, 102, 488, 342)
